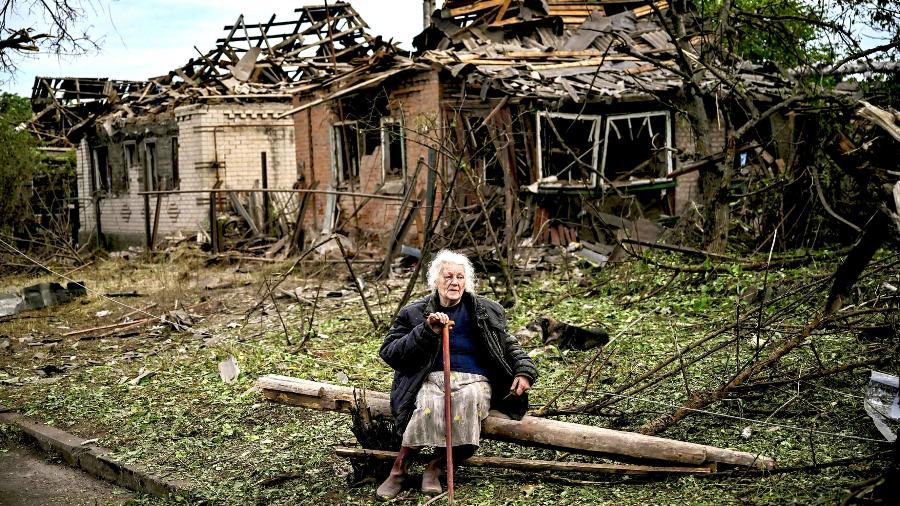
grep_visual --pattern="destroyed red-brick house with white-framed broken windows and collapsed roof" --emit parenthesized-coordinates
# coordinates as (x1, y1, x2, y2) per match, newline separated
(292, 0, 786, 251)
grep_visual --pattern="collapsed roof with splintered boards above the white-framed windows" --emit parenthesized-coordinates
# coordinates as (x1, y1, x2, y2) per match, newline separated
(414, 0, 786, 103)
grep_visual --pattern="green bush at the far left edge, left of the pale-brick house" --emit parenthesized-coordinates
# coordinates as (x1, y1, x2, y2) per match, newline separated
(0, 93, 37, 230)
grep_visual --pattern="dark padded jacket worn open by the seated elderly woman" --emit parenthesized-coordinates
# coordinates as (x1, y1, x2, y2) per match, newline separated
(379, 292, 538, 434)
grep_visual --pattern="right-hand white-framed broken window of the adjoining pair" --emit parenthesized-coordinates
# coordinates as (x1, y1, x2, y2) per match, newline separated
(600, 111, 672, 182)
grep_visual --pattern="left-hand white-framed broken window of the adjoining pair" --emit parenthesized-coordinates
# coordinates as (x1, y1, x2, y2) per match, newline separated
(537, 112, 600, 187)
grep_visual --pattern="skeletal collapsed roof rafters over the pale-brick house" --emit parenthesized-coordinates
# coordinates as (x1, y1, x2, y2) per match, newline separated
(32, 2, 397, 146)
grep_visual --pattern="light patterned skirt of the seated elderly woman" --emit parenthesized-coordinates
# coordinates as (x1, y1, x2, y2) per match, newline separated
(403, 371, 491, 447)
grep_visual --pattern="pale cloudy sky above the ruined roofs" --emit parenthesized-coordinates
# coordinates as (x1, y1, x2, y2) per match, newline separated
(0, 0, 440, 97)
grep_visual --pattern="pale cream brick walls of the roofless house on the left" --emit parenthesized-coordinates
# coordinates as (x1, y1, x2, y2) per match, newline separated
(77, 103, 297, 244)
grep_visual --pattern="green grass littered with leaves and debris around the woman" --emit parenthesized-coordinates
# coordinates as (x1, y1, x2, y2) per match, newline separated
(0, 243, 897, 505)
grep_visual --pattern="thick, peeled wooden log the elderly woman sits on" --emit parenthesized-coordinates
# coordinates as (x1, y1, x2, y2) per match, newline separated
(256, 375, 775, 469)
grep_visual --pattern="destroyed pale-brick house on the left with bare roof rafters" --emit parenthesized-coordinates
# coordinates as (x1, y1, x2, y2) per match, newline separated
(33, 3, 386, 245)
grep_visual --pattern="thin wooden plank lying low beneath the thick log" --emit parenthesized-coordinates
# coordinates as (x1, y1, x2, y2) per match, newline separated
(334, 446, 716, 475)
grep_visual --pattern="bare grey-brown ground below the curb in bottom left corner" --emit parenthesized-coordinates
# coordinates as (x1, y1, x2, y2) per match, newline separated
(0, 444, 134, 506)
